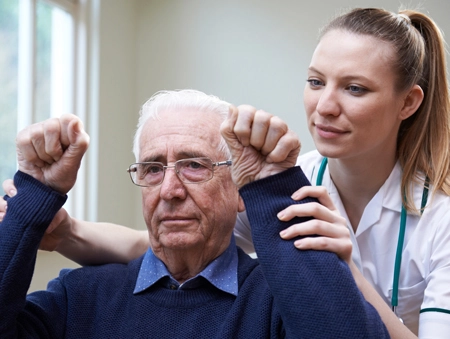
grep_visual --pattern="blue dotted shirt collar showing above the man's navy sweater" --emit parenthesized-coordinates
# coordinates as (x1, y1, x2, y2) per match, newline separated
(133, 236, 238, 296)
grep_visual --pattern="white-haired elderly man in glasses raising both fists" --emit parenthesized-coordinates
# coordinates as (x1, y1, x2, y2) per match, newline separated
(0, 91, 388, 339)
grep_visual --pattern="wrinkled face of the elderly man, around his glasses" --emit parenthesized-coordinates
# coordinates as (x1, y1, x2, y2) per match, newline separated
(139, 109, 242, 256)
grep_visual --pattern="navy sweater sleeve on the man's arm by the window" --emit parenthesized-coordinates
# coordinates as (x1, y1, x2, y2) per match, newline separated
(0, 171, 67, 338)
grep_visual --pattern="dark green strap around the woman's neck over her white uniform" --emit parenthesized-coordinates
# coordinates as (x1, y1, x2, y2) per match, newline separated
(316, 158, 429, 322)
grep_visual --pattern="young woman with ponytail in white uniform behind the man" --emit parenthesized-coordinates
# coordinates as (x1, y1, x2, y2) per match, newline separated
(0, 9, 450, 338)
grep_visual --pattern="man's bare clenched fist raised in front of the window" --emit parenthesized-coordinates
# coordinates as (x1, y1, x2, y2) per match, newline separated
(16, 114, 89, 194)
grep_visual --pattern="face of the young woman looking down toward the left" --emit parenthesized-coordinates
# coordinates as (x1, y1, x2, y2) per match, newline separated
(304, 30, 404, 159)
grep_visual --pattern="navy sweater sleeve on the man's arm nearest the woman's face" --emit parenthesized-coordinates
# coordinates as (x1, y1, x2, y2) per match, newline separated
(240, 167, 389, 339)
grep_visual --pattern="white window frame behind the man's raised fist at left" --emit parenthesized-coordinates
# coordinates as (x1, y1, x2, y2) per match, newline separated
(17, 0, 100, 221)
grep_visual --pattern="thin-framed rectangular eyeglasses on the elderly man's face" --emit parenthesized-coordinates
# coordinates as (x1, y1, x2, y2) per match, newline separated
(127, 158, 231, 187)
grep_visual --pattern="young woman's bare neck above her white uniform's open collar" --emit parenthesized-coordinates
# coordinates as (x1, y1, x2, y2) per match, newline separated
(328, 154, 396, 232)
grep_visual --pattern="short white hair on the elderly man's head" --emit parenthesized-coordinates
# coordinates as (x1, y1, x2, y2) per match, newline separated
(133, 89, 231, 162)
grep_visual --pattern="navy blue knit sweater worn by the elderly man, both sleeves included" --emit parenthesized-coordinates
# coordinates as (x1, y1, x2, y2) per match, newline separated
(0, 168, 388, 339)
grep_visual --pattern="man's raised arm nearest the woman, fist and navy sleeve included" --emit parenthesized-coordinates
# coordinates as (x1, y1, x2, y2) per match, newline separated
(221, 106, 389, 339)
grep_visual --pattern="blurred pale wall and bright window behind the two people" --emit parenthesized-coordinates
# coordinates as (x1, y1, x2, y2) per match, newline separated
(0, 0, 450, 290)
